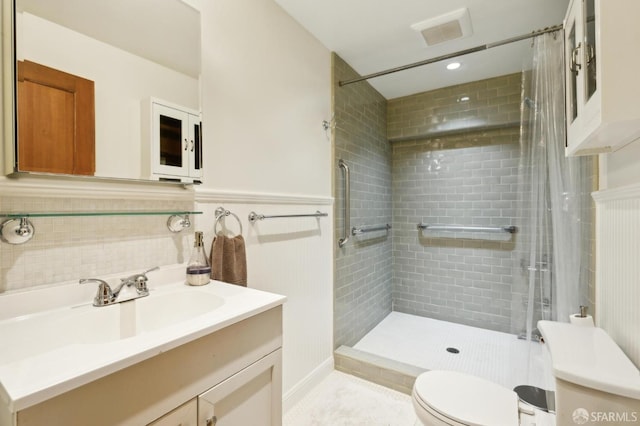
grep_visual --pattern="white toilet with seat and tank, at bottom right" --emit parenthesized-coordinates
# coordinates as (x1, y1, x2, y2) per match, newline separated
(412, 321, 640, 426)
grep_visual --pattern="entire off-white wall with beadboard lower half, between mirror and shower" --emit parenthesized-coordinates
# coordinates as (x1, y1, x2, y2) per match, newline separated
(196, 0, 333, 408)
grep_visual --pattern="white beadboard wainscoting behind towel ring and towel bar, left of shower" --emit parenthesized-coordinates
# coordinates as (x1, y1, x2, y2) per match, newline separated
(195, 189, 333, 411)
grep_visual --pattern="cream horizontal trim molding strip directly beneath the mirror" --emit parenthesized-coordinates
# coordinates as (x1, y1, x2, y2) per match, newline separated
(0, 178, 194, 202)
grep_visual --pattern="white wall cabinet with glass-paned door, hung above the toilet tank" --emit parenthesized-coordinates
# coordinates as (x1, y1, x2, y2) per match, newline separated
(564, 0, 640, 155)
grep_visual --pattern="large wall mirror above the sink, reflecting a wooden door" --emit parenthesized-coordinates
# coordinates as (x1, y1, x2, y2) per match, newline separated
(2, 0, 202, 183)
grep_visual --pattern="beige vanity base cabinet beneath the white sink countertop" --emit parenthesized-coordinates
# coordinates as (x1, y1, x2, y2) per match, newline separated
(11, 305, 282, 426)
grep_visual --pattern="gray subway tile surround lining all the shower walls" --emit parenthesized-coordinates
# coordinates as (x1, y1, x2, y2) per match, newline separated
(334, 56, 597, 347)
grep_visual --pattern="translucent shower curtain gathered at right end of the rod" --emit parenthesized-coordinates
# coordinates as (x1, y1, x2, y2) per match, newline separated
(512, 33, 590, 340)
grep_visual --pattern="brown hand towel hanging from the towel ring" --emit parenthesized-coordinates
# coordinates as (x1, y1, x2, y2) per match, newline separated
(211, 234, 247, 287)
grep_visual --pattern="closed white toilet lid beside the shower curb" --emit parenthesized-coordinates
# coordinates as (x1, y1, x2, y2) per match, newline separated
(413, 370, 518, 426)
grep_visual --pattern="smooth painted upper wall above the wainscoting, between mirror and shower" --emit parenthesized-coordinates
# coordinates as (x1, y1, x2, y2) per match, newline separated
(202, 0, 331, 196)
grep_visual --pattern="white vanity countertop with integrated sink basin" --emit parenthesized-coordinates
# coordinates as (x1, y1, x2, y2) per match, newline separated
(0, 264, 286, 412)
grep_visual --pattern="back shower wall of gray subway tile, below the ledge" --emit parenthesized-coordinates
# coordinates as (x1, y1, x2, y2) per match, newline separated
(393, 129, 520, 331)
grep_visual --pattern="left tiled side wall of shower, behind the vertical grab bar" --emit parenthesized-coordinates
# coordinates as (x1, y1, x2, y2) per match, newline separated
(333, 55, 392, 348)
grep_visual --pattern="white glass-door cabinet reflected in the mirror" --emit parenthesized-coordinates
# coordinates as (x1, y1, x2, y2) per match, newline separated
(142, 98, 202, 183)
